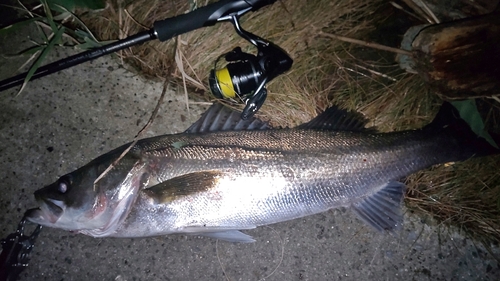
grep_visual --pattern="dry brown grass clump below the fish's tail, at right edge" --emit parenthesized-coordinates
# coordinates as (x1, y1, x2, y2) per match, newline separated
(406, 156, 500, 242)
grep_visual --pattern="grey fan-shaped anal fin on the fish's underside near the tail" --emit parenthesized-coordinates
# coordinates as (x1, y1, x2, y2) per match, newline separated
(352, 181, 405, 231)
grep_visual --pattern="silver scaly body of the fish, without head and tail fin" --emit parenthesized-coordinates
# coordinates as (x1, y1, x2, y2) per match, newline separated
(114, 129, 439, 237)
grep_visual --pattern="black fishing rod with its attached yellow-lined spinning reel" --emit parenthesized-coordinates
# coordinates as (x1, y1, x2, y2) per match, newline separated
(0, 0, 292, 119)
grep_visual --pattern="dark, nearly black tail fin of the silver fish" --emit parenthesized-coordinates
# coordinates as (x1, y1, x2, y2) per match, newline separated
(424, 102, 500, 160)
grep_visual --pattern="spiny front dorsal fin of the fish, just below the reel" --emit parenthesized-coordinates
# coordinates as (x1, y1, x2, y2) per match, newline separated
(185, 103, 271, 133)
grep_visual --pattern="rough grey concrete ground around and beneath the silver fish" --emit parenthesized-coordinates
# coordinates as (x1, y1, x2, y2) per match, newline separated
(0, 9, 500, 281)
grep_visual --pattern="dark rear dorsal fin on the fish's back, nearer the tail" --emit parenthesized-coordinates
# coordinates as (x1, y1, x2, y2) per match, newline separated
(297, 106, 370, 131)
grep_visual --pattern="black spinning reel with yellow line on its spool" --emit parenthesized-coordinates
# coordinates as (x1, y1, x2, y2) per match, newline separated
(209, 11, 293, 119)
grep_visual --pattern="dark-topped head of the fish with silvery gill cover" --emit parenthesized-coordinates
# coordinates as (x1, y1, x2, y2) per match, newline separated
(26, 151, 142, 234)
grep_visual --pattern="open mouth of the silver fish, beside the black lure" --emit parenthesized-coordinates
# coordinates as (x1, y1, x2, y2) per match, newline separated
(26, 198, 64, 225)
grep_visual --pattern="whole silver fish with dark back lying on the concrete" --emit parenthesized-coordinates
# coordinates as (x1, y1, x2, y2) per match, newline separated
(26, 103, 500, 243)
